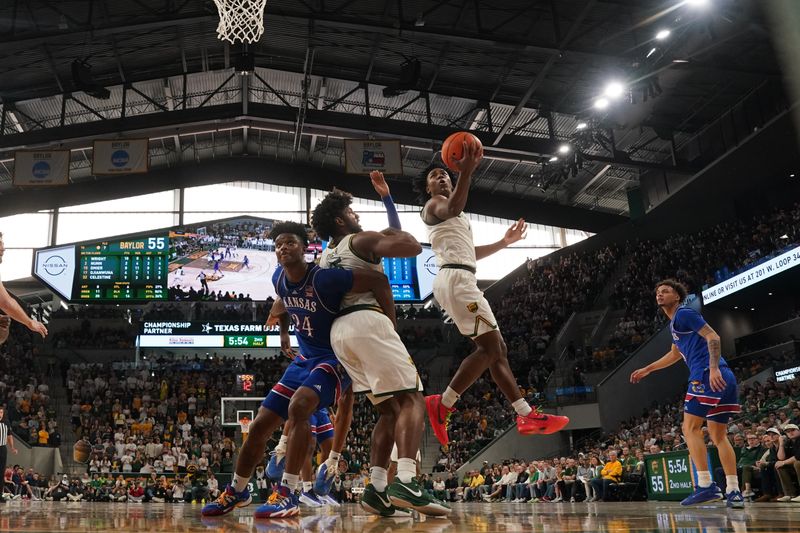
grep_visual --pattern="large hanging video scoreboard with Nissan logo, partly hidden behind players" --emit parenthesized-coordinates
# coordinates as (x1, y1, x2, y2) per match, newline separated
(33, 217, 436, 303)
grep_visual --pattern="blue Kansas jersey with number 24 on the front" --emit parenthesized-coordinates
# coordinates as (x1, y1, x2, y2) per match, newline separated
(272, 265, 353, 359)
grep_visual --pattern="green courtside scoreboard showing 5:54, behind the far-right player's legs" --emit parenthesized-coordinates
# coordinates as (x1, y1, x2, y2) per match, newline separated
(644, 448, 720, 501)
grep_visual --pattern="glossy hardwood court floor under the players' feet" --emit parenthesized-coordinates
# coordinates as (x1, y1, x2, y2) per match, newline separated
(0, 501, 800, 533)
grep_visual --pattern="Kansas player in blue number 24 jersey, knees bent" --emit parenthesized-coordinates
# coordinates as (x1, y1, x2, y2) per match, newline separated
(202, 222, 395, 518)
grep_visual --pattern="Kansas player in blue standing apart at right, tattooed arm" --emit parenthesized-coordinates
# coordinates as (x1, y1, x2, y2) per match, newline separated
(631, 279, 744, 508)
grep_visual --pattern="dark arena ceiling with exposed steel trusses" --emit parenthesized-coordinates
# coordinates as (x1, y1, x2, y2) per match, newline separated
(0, 0, 781, 231)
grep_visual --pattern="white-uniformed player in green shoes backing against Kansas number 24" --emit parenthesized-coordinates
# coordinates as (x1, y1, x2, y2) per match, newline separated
(311, 179, 450, 516)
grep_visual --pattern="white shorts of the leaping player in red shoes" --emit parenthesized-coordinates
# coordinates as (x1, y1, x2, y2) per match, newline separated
(433, 268, 497, 339)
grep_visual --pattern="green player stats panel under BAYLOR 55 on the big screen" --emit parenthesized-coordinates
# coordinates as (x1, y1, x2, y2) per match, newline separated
(78, 236, 169, 300)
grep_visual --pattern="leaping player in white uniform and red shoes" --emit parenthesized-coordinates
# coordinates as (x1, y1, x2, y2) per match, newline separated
(416, 143, 569, 446)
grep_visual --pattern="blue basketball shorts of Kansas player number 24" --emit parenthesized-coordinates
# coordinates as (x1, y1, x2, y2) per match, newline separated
(261, 355, 351, 420)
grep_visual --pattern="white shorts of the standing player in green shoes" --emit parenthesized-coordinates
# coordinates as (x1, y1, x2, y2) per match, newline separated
(331, 309, 422, 404)
